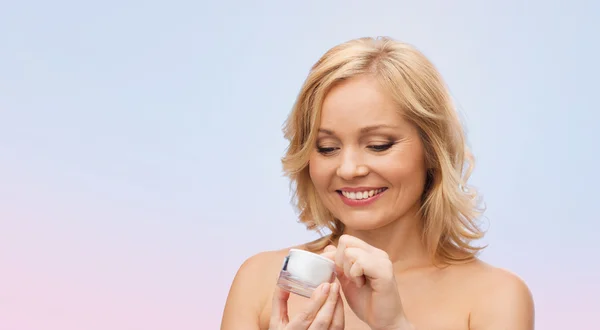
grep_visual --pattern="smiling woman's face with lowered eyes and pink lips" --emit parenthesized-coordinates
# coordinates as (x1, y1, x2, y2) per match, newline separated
(309, 76, 426, 230)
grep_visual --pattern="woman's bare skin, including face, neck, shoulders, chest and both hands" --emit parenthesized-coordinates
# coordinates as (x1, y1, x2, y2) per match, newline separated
(221, 76, 534, 330)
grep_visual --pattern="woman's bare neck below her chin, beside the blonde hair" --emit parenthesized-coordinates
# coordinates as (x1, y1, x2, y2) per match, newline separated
(344, 208, 432, 272)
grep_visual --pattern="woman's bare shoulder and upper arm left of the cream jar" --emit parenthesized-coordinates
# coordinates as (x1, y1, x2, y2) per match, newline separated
(221, 246, 303, 330)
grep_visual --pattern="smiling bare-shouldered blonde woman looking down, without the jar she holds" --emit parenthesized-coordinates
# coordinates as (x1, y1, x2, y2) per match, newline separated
(221, 38, 534, 330)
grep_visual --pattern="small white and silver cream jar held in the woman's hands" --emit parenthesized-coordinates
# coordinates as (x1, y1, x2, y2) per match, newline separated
(277, 249, 335, 298)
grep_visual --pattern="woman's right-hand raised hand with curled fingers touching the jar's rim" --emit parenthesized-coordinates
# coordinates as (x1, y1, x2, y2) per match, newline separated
(324, 235, 412, 330)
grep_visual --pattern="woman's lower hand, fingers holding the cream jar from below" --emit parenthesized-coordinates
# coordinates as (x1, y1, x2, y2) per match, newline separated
(269, 283, 344, 330)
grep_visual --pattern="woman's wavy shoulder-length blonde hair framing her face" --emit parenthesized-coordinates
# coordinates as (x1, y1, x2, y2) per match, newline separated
(282, 37, 484, 264)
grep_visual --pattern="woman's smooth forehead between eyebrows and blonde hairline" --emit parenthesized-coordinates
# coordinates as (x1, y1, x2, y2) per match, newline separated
(321, 76, 404, 131)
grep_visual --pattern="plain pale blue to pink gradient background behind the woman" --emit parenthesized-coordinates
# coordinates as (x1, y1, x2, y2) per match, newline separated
(0, 0, 600, 330)
